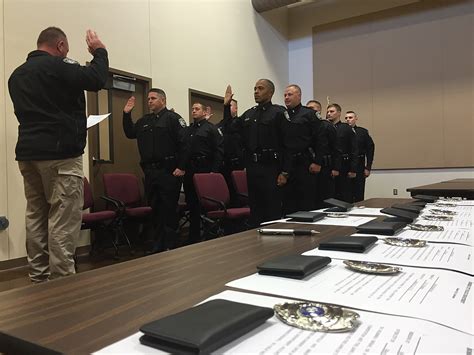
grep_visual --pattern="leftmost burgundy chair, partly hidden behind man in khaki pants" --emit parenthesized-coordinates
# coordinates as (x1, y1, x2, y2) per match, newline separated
(81, 177, 118, 255)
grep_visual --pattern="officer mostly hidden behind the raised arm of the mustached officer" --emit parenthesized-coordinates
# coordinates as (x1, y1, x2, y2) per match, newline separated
(217, 86, 244, 206)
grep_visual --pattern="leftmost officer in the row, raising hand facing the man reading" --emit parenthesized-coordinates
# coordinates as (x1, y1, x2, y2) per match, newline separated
(123, 89, 186, 253)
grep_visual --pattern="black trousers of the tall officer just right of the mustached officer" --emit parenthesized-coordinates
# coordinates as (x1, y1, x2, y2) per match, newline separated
(283, 158, 316, 215)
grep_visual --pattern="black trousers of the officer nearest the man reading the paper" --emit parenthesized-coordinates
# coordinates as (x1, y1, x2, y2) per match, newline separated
(143, 167, 181, 252)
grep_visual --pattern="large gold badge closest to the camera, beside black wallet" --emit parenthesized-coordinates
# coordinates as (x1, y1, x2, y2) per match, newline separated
(273, 302, 359, 333)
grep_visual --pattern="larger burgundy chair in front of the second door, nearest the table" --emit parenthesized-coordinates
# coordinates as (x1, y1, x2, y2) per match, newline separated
(193, 173, 250, 236)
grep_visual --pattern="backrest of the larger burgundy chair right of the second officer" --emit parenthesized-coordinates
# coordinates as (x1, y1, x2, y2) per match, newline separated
(193, 173, 230, 211)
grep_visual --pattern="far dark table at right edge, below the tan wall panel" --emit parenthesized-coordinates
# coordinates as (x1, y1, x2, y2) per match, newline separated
(407, 178, 474, 200)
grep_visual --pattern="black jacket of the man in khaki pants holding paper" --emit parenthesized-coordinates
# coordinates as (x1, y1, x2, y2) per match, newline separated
(8, 48, 109, 160)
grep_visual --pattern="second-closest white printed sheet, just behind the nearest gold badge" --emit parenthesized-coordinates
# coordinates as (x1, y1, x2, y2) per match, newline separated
(227, 259, 474, 335)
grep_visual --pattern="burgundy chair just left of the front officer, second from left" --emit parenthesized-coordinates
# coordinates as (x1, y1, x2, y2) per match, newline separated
(103, 173, 152, 250)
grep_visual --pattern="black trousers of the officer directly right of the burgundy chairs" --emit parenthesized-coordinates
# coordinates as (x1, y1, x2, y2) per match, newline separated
(246, 160, 281, 227)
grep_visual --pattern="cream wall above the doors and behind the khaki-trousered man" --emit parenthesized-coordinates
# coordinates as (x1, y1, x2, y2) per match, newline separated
(0, 0, 288, 260)
